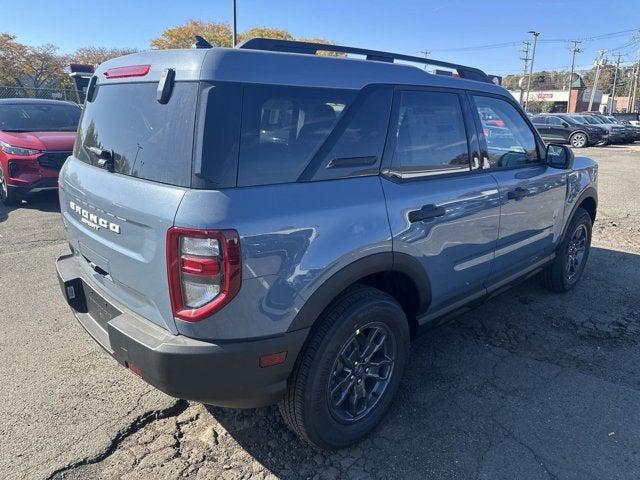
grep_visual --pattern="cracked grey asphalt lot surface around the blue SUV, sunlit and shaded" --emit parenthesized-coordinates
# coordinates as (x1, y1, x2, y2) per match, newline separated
(0, 146, 640, 480)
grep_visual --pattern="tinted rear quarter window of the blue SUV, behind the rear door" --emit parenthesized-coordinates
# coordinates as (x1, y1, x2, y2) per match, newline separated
(238, 85, 356, 186)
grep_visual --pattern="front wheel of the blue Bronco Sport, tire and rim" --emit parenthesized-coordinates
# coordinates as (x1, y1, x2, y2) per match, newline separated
(540, 208, 592, 293)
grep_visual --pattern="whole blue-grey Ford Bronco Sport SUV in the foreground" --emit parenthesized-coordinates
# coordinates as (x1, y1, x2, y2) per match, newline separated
(57, 39, 598, 449)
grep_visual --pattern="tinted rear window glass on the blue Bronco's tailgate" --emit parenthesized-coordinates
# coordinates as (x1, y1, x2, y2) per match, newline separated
(74, 82, 198, 187)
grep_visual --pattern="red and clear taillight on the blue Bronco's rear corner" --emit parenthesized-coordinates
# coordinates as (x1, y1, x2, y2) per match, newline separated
(167, 227, 242, 322)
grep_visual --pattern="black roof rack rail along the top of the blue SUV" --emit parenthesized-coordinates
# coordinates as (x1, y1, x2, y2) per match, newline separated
(237, 38, 493, 83)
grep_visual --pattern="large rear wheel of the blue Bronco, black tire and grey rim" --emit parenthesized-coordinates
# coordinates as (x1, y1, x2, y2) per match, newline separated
(279, 286, 409, 450)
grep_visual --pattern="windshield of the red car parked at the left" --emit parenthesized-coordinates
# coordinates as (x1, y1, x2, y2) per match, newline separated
(0, 103, 81, 132)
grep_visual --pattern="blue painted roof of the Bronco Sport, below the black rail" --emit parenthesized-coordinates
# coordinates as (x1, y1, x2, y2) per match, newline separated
(96, 48, 508, 95)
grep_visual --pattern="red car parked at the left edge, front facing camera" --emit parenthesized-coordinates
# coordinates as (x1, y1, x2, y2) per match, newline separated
(0, 98, 82, 205)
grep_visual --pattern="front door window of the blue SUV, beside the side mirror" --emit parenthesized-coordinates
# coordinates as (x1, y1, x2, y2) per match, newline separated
(473, 96, 539, 168)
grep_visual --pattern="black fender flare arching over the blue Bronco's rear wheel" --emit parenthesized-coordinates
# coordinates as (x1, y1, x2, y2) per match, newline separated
(288, 252, 431, 331)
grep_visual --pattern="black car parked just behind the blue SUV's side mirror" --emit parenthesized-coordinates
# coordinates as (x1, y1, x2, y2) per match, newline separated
(531, 114, 609, 148)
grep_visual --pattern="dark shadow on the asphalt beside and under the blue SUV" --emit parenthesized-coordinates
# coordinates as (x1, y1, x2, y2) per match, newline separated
(204, 248, 640, 479)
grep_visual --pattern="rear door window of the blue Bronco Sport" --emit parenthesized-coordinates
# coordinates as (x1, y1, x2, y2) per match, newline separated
(393, 90, 470, 178)
